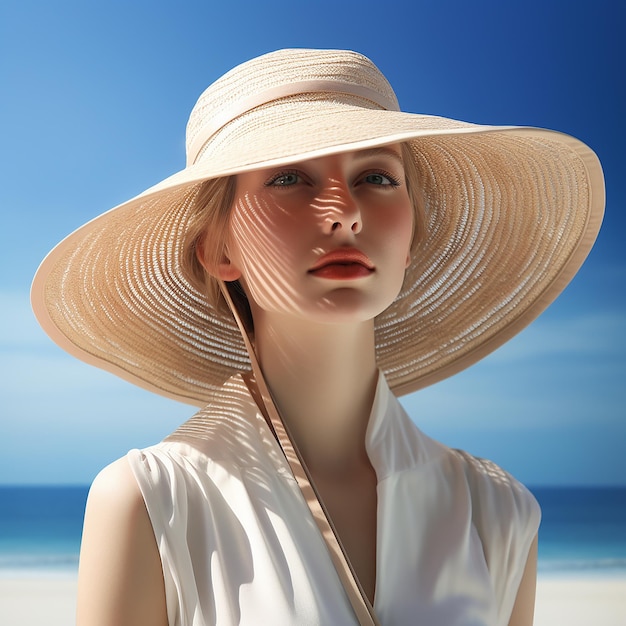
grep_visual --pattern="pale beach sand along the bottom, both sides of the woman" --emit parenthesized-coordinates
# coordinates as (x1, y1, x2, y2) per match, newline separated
(0, 576, 626, 626)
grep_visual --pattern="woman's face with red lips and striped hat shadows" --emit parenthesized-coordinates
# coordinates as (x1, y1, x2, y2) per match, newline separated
(221, 146, 414, 323)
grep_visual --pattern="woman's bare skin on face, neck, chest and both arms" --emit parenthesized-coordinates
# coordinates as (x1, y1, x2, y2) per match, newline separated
(77, 148, 536, 626)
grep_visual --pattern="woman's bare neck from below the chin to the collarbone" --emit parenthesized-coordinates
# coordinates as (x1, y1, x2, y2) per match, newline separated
(255, 310, 378, 474)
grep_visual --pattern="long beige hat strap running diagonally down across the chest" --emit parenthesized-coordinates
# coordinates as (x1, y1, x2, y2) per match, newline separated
(219, 281, 379, 626)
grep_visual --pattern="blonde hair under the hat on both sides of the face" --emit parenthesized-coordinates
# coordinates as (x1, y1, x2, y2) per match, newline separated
(182, 143, 426, 329)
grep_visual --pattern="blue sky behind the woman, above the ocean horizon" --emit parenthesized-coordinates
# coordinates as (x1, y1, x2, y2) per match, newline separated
(0, 0, 626, 485)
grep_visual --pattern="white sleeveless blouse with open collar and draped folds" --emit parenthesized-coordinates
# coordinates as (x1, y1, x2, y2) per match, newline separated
(128, 374, 540, 626)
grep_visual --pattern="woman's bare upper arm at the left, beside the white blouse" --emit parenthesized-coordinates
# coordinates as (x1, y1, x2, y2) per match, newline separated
(77, 459, 168, 626)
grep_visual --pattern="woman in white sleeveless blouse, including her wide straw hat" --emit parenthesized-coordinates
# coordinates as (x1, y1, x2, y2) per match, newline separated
(33, 50, 604, 626)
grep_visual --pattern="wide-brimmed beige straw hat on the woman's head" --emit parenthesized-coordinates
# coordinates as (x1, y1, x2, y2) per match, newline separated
(32, 49, 604, 405)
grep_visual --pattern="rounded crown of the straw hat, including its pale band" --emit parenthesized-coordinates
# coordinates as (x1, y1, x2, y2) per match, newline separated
(187, 48, 400, 165)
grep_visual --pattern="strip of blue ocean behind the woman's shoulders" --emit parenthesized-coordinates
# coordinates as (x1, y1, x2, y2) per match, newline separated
(0, 486, 626, 577)
